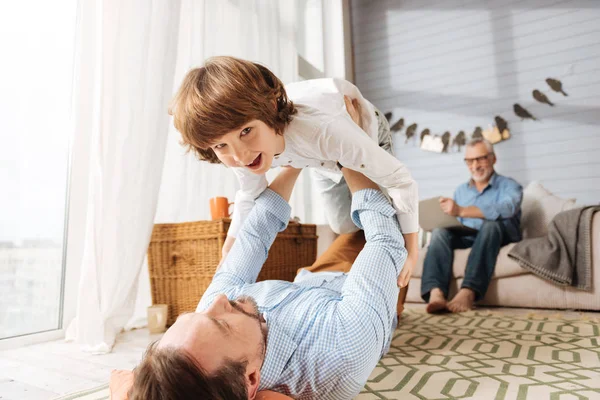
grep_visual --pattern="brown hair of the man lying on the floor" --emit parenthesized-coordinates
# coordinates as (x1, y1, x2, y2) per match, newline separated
(128, 342, 248, 400)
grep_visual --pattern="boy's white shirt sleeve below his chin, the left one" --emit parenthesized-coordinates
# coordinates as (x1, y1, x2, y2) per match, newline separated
(227, 168, 269, 237)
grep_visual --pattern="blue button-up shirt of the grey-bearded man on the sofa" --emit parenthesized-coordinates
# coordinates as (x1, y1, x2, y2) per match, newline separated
(454, 173, 523, 242)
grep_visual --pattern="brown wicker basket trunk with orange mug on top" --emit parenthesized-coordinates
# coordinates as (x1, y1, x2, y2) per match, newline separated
(148, 219, 317, 325)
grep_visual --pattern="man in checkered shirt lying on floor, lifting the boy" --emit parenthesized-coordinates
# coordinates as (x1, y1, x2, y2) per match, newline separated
(129, 168, 407, 400)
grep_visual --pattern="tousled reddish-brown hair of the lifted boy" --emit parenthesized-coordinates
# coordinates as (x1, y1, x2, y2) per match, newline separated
(169, 56, 296, 164)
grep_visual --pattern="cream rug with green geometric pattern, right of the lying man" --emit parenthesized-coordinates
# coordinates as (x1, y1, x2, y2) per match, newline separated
(357, 309, 600, 400)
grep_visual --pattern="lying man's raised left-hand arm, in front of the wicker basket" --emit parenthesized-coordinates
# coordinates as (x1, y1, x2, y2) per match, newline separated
(207, 167, 301, 292)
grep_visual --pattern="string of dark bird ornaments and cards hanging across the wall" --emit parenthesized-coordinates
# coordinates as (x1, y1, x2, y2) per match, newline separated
(385, 78, 568, 153)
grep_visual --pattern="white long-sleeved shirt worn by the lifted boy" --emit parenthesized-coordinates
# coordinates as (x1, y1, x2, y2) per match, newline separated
(228, 78, 419, 237)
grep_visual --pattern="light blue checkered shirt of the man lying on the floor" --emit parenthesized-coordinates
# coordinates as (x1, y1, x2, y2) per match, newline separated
(196, 189, 407, 400)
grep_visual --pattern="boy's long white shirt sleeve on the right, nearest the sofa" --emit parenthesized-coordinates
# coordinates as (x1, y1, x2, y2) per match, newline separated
(317, 114, 419, 233)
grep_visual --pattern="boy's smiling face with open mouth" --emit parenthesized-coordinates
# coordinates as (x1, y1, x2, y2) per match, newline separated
(210, 120, 285, 174)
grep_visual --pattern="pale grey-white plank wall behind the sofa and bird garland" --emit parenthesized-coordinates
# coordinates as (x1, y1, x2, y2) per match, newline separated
(352, 0, 600, 204)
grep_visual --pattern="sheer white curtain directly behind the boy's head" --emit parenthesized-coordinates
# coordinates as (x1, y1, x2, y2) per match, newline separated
(155, 0, 297, 223)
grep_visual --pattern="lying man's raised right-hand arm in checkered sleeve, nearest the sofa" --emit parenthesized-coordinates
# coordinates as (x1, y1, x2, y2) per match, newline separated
(338, 168, 407, 370)
